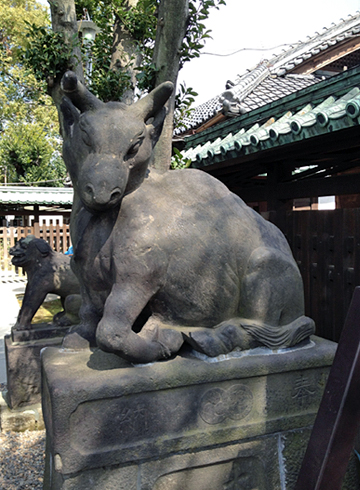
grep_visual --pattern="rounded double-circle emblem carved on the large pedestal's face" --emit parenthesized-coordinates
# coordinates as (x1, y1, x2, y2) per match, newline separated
(200, 384, 253, 425)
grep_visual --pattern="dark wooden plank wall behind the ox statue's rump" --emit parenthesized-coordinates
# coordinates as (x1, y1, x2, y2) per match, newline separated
(282, 209, 360, 341)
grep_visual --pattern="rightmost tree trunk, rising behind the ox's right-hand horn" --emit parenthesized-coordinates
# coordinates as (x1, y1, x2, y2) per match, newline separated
(152, 0, 189, 171)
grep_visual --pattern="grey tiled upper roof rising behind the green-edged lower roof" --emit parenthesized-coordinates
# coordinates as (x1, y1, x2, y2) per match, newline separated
(175, 12, 360, 137)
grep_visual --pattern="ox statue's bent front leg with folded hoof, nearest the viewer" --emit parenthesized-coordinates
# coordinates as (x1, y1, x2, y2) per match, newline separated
(96, 284, 183, 363)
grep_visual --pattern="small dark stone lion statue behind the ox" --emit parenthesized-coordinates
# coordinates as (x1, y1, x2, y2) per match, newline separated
(10, 235, 81, 330)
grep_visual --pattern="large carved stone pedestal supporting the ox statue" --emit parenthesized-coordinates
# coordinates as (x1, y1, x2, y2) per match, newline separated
(42, 337, 356, 490)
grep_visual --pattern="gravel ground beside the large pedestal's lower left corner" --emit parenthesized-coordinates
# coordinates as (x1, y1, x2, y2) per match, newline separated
(0, 384, 45, 490)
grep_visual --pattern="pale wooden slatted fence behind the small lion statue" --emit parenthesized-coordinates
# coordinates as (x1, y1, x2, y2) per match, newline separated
(0, 223, 70, 281)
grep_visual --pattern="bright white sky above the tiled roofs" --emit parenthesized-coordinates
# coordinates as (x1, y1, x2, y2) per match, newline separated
(178, 0, 360, 105)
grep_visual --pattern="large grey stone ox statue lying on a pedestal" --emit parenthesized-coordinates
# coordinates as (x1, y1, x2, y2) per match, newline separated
(61, 72, 314, 363)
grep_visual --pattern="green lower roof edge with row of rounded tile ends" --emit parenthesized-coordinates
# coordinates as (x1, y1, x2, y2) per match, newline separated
(182, 67, 360, 167)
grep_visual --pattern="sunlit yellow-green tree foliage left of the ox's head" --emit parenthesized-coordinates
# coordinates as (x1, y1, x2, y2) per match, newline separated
(0, 0, 65, 186)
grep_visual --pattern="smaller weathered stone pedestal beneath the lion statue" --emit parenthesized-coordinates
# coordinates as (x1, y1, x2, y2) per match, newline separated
(4, 323, 68, 409)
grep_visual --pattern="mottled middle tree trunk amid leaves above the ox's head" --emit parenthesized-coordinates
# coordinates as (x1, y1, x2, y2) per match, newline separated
(110, 0, 142, 104)
